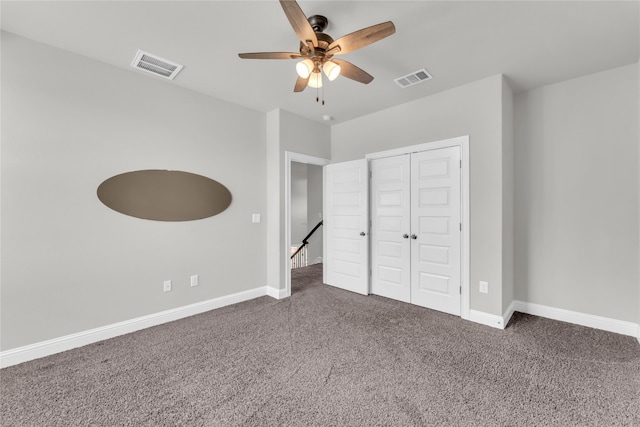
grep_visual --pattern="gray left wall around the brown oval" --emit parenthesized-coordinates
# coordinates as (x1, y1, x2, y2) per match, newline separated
(1, 33, 266, 350)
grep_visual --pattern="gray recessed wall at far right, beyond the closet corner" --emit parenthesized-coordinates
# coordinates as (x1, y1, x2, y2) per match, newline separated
(515, 64, 640, 323)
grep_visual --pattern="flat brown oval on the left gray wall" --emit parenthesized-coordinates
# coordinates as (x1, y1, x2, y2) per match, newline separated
(98, 170, 231, 221)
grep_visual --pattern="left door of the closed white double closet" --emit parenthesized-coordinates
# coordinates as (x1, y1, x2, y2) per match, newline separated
(371, 155, 411, 302)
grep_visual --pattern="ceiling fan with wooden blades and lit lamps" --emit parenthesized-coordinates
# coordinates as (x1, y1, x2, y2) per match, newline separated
(238, 0, 396, 97)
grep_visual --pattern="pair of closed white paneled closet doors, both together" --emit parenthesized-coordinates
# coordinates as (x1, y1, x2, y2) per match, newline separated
(371, 147, 462, 315)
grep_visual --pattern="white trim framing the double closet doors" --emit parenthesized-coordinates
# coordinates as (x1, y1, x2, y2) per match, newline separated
(365, 135, 471, 320)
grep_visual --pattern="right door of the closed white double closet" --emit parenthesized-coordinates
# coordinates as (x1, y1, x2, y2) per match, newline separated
(411, 147, 461, 316)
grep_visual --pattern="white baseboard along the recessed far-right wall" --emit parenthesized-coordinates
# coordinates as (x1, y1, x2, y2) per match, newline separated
(510, 301, 640, 341)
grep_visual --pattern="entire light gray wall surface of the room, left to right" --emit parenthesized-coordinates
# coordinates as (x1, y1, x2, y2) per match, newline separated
(0, 33, 640, 350)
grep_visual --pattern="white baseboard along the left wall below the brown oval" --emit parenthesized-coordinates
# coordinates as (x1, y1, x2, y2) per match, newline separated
(0, 286, 268, 368)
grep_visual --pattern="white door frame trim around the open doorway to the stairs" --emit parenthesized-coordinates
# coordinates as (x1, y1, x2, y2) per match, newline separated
(281, 151, 331, 298)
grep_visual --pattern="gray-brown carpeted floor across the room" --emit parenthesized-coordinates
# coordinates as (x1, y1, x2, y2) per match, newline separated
(0, 265, 640, 427)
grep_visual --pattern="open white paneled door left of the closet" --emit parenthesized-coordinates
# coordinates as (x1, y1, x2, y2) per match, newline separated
(323, 159, 369, 295)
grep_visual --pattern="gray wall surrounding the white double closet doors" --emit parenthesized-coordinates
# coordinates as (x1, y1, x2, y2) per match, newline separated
(331, 75, 511, 315)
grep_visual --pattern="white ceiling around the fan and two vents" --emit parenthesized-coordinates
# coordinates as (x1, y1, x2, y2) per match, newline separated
(0, 0, 640, 123)
